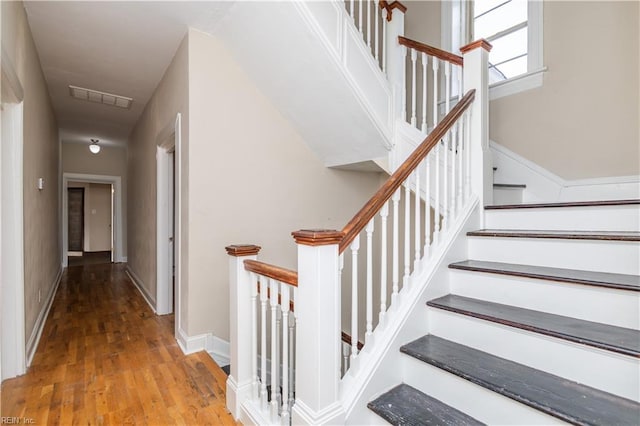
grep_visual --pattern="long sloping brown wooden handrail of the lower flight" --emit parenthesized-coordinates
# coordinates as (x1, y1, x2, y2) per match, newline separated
(340, 89, 476, 251)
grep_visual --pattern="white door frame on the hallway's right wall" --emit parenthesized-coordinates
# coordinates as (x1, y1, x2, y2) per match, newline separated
(156, 113, 182, 322)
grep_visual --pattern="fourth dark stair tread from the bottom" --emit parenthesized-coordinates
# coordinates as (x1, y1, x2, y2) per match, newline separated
(449, 260, 640, 291)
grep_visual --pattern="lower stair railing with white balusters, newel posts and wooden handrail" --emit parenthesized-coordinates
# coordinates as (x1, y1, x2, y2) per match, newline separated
(227, 41, 491, 424)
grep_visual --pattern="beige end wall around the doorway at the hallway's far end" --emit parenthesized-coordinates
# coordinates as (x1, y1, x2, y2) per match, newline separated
(62, 142, 127, 257)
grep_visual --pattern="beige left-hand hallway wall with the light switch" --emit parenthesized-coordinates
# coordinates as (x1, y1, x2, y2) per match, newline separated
(1, 1, 61, 341)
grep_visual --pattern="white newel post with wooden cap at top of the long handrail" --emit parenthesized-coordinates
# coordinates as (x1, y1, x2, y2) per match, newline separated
(460, 40, 493, 211)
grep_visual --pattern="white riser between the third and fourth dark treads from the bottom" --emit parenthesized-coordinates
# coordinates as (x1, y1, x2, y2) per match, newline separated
(450, 269, 640, 330)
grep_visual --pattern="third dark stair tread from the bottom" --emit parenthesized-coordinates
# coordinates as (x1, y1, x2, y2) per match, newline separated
(427, 294, 640, 358)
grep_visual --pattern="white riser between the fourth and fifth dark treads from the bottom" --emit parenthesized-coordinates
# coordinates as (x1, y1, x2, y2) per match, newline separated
(468, 237, 640, 275)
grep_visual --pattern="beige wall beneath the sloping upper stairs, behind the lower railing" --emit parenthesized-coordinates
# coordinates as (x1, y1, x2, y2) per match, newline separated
(188, 31, 380, 340)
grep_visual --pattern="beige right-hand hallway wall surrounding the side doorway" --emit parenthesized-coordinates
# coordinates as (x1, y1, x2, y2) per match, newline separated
(127, 33, 189, 310)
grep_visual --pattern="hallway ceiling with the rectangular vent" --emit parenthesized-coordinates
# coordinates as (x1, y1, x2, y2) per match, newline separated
(24, 1, 233, 146)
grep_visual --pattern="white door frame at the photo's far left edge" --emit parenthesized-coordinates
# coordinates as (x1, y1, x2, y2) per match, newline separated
(0, 47, 27, 379)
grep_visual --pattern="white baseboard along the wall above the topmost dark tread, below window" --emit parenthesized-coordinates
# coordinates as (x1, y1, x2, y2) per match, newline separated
(490, 141, 640, 203)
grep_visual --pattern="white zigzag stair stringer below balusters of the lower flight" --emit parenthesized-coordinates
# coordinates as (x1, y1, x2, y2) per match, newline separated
(340, 197, 482, 425)
